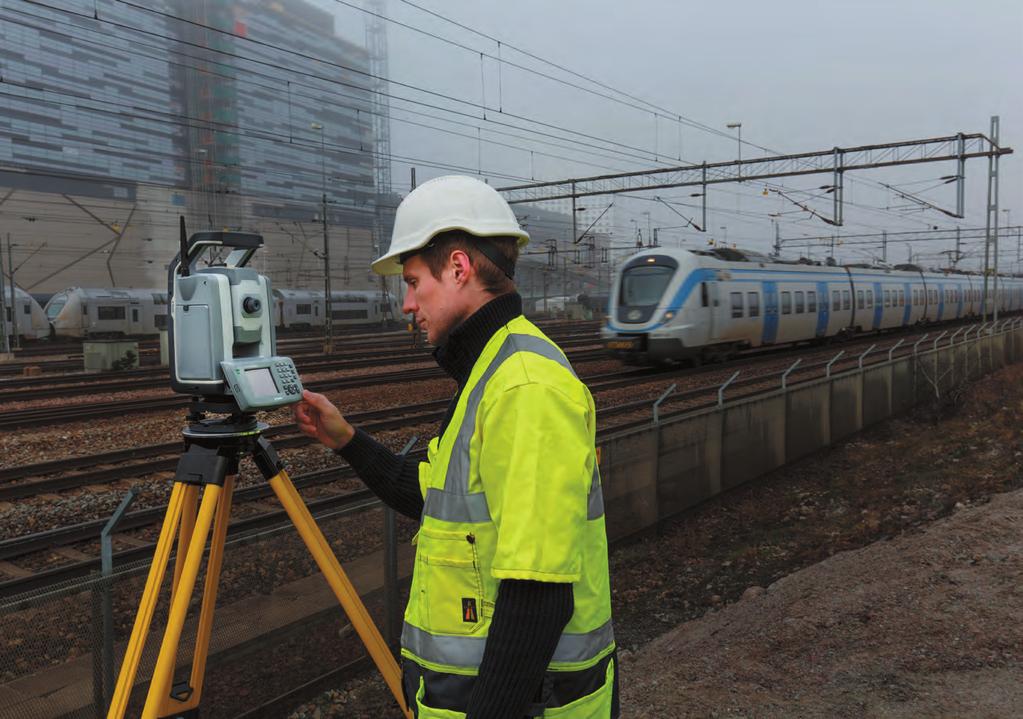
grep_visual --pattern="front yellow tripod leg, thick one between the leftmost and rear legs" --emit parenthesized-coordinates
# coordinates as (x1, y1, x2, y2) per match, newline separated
(142, 485, 223, 719)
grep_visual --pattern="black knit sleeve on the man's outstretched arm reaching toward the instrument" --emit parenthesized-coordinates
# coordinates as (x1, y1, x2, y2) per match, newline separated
(337, 429, 422, 520)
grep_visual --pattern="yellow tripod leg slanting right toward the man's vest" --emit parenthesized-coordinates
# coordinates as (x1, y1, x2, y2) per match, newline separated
(261, 466, 411, 718)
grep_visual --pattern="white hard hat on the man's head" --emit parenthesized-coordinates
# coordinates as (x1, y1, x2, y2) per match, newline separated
(371, 175, 529, 275)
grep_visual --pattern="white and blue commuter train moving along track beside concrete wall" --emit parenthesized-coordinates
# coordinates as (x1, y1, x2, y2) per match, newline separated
(602, 248, 1023, 364)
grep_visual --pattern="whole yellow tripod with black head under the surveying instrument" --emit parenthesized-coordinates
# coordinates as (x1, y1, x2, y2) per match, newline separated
(106, 416, 411, 719)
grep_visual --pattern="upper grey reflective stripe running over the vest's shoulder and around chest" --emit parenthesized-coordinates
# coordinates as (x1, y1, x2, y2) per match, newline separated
(422, 334, 604, 524)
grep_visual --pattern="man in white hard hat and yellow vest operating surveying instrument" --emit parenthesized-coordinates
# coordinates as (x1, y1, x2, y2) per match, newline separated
(295, 176, 619, 719)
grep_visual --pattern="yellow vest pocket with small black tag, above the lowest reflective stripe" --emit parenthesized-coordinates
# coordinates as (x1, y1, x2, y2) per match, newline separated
(416, 525, 485, 634)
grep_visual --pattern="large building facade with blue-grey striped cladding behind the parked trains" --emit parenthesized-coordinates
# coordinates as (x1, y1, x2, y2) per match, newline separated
(0, 0, 384, 291)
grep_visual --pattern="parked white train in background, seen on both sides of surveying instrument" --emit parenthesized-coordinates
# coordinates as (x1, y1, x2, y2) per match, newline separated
(45, 287, 401, 339)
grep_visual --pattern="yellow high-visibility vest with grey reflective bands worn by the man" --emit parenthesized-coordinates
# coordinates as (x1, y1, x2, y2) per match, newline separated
(401, 316, 616, 719)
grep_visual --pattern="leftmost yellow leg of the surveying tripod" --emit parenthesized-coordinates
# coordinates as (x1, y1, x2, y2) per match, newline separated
(106, 483, 185, 719)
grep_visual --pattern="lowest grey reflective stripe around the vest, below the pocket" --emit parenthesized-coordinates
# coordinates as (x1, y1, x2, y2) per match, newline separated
(401, 620, 615, 667)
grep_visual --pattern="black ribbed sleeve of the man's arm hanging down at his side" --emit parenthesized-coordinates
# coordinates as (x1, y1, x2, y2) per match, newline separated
(466, 579, 575, 719)
